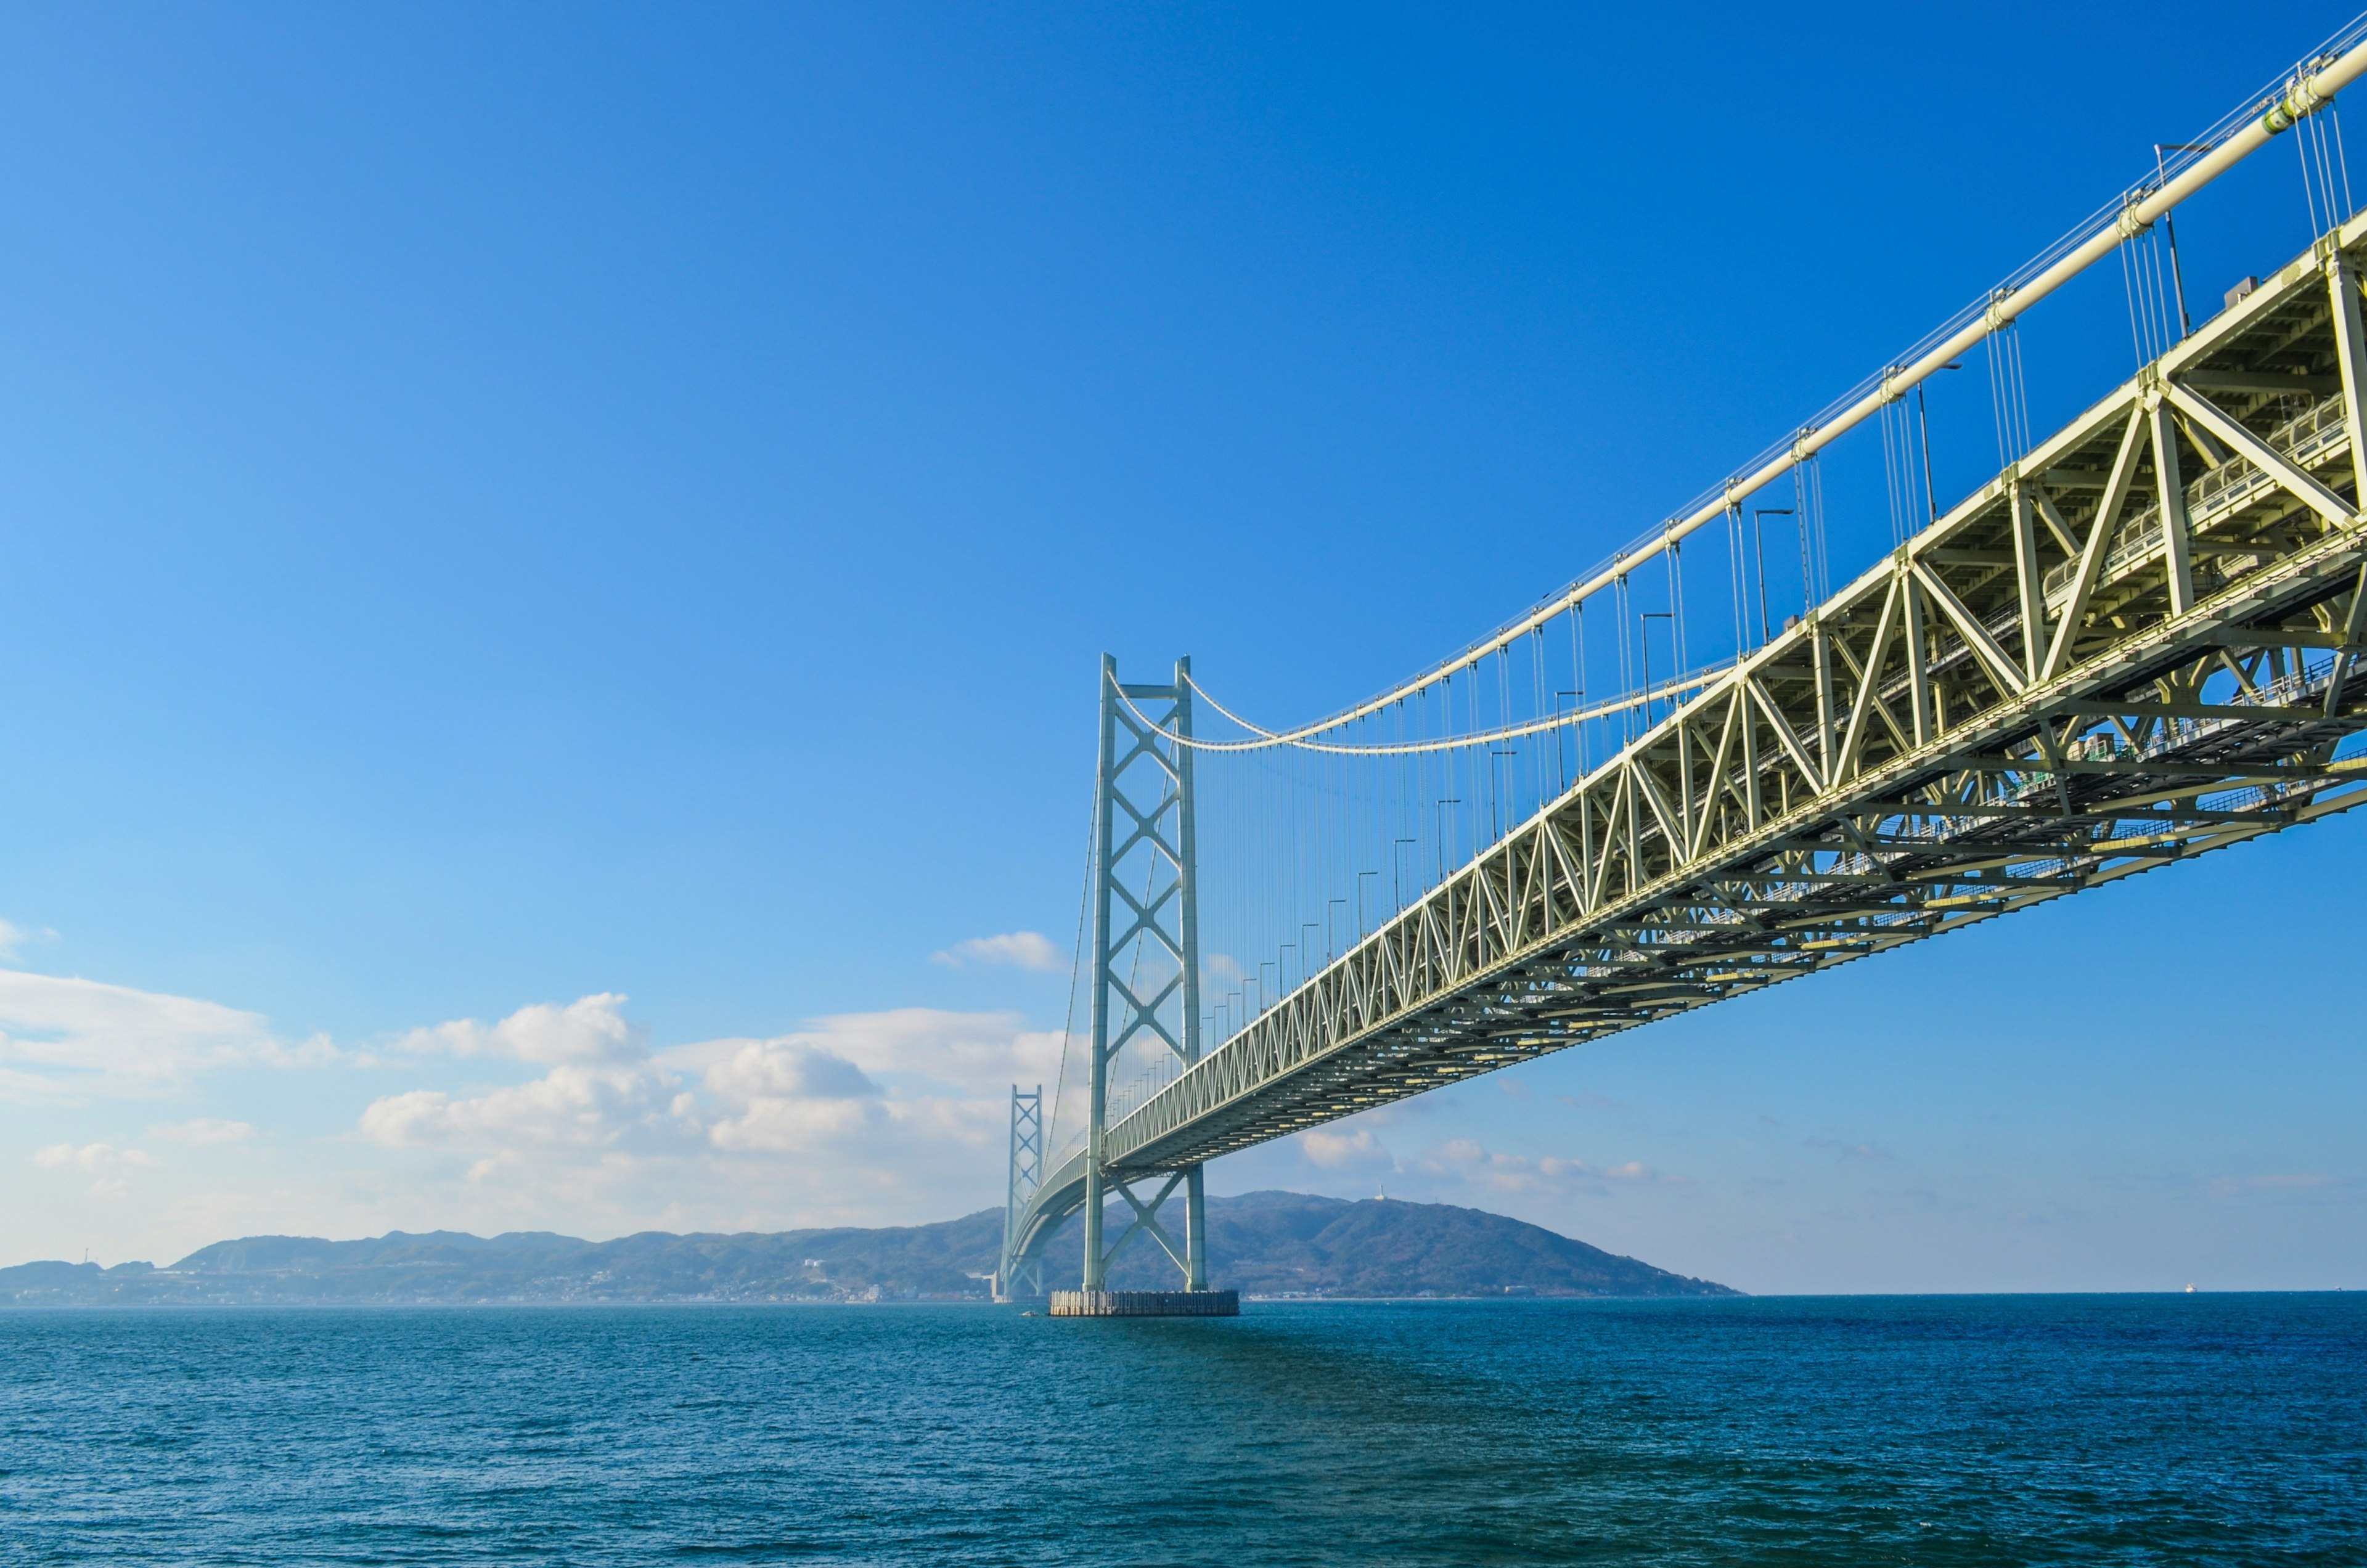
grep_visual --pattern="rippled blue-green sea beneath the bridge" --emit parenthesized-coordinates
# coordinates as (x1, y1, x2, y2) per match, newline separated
(0, 1293, 2367, 1568)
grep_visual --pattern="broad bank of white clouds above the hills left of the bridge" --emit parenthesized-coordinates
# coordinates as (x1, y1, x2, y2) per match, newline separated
(0, 990, 1063, 1256)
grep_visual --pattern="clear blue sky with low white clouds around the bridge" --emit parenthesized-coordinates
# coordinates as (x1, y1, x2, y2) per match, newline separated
(0, 5, 2367, 1291)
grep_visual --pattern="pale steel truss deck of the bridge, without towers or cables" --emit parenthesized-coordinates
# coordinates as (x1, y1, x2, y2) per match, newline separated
(1094, 218, 2367, 1184)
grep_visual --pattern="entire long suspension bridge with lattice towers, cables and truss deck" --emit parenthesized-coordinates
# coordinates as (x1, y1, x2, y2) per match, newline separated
(997, 23, 2367, 1315)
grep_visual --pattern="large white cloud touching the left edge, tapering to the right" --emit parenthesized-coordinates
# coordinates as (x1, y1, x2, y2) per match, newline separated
(0, 969, 336, 1101)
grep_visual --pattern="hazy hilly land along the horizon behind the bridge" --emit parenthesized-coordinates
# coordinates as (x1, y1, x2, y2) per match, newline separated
(0, 1191, 1735, 1305)
